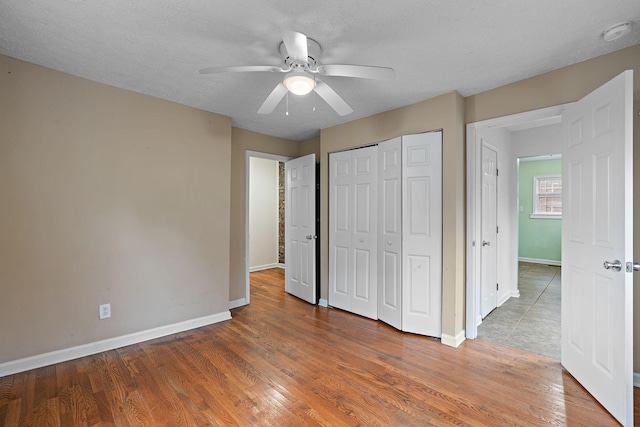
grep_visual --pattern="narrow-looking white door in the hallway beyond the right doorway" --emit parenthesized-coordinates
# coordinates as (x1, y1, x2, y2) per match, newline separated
(480, 140, 498, 319)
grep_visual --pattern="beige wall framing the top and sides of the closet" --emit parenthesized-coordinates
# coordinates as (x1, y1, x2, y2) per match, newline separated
(320, 92, 464, 338)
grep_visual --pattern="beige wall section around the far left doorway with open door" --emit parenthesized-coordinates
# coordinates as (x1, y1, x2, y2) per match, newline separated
(229, 128, 300, 301)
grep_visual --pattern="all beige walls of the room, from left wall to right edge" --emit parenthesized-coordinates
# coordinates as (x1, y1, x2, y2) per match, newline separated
(0, 46, 640, 371)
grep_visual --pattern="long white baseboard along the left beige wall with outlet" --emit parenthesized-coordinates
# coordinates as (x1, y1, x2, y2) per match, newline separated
(0, 310, 231, 377)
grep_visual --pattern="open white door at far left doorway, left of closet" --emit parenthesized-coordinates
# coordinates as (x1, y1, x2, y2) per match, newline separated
(284, 154, 317, 304)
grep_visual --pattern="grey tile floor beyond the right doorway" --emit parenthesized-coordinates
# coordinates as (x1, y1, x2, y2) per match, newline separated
(478, 262, 560, 360)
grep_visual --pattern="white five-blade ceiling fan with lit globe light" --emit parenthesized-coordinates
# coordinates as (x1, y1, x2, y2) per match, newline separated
(200, 31, 395, 116)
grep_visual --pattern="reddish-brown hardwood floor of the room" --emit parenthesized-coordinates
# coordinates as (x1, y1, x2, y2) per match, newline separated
(0, 269, 637, 426)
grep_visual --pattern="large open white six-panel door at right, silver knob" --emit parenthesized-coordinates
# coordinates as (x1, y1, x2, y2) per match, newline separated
(562, 71, 633, 426)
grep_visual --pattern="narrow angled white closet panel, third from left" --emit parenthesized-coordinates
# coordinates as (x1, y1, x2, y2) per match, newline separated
(378, 138, 402, 329)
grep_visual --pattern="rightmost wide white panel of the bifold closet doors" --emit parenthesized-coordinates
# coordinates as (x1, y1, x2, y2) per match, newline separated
(402, 132, 442, 337)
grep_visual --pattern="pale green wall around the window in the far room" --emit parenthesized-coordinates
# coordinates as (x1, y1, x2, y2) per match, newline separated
(518, 159, 562, 262)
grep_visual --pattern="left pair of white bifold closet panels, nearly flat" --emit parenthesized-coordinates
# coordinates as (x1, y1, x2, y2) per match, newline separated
(329, 147, 378, 319)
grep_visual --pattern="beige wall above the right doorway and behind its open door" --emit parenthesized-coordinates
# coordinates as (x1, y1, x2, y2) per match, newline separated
(465, 45, 640, 372)
